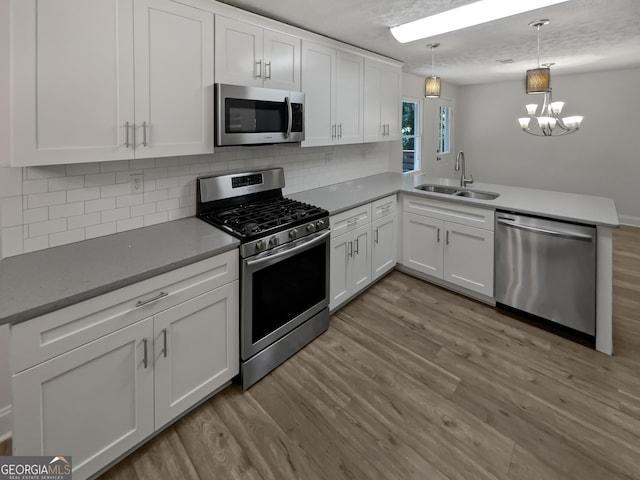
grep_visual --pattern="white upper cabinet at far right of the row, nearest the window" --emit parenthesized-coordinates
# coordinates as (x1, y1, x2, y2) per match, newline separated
(364, 58, 402, 142)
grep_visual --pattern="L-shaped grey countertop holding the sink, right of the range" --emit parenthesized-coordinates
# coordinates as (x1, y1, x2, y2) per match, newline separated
(288, 173, 619, 228)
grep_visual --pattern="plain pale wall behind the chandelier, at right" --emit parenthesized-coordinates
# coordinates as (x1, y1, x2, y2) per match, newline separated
(456, 69, 640, 226)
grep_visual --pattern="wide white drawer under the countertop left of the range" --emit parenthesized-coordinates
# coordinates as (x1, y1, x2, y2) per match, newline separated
(11, 250, 238, 373)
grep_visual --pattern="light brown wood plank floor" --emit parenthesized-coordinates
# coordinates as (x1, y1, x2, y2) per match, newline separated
(1, 227, 640, 480)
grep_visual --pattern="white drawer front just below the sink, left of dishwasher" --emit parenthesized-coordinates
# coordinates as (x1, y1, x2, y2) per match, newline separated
(402, 196, 495, 231)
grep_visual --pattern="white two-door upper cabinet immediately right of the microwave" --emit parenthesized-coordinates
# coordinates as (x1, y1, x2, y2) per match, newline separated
(302, 41, 364, 147)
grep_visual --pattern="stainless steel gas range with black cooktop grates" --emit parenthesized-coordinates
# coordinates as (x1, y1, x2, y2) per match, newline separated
(196, 168, 330, 389)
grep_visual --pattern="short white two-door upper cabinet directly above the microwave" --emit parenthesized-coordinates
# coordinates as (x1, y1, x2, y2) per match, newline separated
(215, 16, 301, 91)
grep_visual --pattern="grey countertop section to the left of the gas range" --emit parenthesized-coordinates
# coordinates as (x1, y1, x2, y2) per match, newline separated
(0, 217, 240, 325)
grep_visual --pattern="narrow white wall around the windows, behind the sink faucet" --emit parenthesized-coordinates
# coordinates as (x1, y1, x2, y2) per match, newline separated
(402, 73, 460, 178)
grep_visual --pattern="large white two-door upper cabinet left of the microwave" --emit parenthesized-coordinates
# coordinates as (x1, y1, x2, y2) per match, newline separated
(11, 0, 213, 166)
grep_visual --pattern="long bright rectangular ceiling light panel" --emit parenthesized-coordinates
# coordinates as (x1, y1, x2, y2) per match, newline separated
(390, 0, 569, 43)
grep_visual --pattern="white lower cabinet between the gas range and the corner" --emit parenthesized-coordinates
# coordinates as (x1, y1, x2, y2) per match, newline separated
(329, 195, 397, 310)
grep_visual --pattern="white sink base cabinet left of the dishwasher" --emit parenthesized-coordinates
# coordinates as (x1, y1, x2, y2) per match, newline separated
(402, 197, 494, 297)
